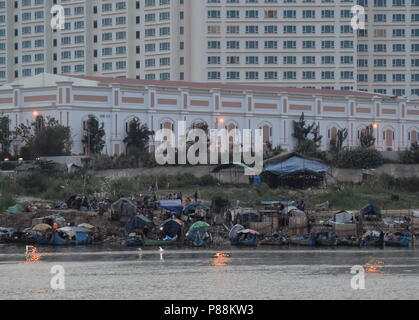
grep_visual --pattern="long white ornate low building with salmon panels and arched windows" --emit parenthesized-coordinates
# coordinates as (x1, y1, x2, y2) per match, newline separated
(0, 74, 419, 155)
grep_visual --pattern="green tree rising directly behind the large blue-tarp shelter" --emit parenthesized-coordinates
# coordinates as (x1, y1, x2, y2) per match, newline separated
(293, 113, 323, 155)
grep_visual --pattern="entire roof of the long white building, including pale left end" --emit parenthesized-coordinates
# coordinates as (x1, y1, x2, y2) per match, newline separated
(0, 73, 389, 98)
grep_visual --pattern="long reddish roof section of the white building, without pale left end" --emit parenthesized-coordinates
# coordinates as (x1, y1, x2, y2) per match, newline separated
(66, 75, 385, 97)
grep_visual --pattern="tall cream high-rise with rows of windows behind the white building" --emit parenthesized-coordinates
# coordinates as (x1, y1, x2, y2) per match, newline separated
(0, 0, 419, 96)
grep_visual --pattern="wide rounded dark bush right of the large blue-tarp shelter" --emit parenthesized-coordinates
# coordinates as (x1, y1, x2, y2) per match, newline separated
(333, 147, 384, 169)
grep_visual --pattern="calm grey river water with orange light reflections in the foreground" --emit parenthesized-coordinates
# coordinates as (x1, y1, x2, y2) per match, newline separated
(0, 245, 419, 300)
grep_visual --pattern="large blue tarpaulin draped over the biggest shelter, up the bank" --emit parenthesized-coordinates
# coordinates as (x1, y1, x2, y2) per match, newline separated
(263, 156, 329, 176)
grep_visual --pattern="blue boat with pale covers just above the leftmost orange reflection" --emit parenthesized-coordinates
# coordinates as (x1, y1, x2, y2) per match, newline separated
(34, 227, 93, 246)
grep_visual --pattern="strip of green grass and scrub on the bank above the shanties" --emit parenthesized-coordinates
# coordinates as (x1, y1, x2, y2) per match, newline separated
(0, 172, 419, 210)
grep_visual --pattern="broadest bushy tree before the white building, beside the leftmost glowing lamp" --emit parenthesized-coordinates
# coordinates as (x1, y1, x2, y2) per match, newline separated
(16, 117, 72, 159)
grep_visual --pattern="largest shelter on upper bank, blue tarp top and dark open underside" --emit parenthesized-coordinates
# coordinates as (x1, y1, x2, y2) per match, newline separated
(262, 153, 330, 188)
